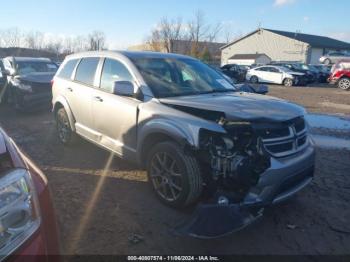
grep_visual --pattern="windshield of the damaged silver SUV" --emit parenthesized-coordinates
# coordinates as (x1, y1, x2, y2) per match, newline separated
(132, 58, 235, 98)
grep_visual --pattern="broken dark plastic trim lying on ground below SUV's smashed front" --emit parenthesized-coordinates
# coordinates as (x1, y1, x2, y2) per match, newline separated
(175, 201, 264, 239)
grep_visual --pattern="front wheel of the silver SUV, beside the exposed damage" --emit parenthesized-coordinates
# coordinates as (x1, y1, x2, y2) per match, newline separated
(147, 142, 203, 208)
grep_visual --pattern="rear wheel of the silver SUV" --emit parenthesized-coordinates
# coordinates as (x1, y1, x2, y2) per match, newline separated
(55, 107, 77, 145)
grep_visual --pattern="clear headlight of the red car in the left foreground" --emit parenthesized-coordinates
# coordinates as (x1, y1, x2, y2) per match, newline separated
(0, 130, 41, 259)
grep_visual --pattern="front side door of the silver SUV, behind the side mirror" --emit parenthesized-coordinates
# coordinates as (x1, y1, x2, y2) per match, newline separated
(92, 58, 141, 156)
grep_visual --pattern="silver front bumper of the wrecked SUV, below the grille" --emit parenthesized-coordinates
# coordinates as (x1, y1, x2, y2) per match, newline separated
(242, 142, 315, 206)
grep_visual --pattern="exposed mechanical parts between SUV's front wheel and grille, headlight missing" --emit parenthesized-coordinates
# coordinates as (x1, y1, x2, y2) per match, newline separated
(200, 118, 271, 202)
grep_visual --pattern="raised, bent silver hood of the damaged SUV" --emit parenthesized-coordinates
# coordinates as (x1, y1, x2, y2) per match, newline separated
(159, 92, 306, 122)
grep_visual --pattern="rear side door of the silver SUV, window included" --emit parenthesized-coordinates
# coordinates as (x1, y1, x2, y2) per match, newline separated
(66, 57, 100, 140)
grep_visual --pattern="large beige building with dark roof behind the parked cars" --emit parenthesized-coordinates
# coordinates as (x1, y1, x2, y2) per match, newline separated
(221, 28, 350, 65)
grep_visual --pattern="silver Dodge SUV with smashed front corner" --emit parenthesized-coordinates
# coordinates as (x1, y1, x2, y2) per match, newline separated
(52, 51, 315, 213)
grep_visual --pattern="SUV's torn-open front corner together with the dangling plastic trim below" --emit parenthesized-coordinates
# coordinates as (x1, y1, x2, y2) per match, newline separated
(177, 117, 271, 238)
